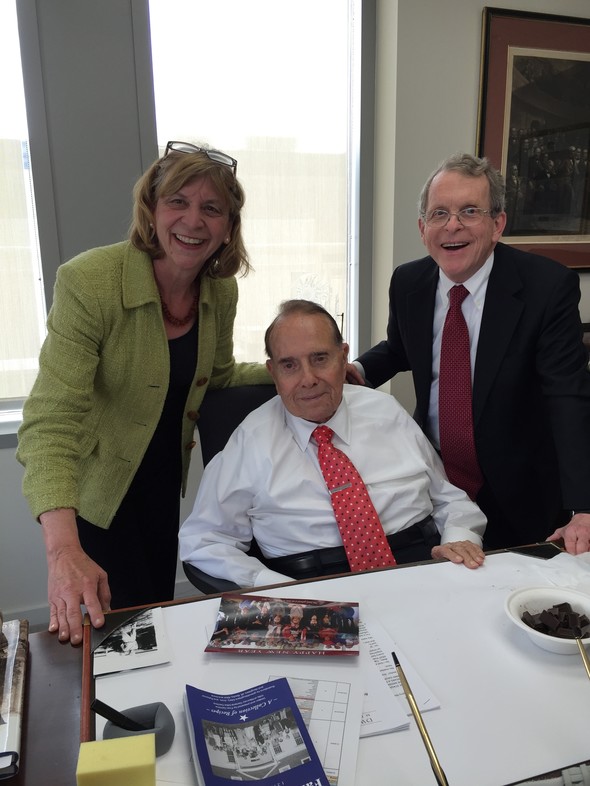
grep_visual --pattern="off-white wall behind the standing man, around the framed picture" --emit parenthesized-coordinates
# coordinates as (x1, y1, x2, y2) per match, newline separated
(373, 0, 590, 411)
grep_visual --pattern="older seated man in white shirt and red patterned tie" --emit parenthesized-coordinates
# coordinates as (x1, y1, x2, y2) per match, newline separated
(179, 300, 486, 587)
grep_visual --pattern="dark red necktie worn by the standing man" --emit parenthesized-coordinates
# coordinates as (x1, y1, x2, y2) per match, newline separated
(438, 284, 483, 499)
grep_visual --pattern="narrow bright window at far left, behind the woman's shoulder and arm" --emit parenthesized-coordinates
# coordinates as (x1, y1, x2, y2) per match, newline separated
(0, 2, 46, 404)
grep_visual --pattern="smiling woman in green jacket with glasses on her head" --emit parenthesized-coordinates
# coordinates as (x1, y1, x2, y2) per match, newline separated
(17, 142, 270, 644)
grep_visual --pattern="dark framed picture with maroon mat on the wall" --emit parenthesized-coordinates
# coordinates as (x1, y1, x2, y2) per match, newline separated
(477, 7, 590, 268)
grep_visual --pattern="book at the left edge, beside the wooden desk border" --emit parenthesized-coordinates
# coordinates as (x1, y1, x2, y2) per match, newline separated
(0, 616, 29, 779)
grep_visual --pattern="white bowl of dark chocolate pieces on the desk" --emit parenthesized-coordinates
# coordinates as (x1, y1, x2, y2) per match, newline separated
(505, 587, 590, 655)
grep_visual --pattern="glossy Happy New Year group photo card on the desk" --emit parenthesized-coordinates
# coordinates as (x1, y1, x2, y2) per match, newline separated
(205, 593, 359, 655)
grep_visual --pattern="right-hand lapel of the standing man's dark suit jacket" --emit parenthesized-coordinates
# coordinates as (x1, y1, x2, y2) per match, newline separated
(473, 244, 524, 425)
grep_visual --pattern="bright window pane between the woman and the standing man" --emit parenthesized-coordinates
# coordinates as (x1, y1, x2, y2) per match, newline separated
(150, 0, 360, 360)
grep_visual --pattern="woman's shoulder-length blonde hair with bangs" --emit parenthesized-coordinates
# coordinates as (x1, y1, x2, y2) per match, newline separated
(129, 151, 251, 278)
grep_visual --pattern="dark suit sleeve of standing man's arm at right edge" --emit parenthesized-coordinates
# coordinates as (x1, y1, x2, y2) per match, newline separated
(536, 266, 590, 509)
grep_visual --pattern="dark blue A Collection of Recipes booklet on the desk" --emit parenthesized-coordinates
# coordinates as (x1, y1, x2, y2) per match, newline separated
(184, 678, 330, 786)
